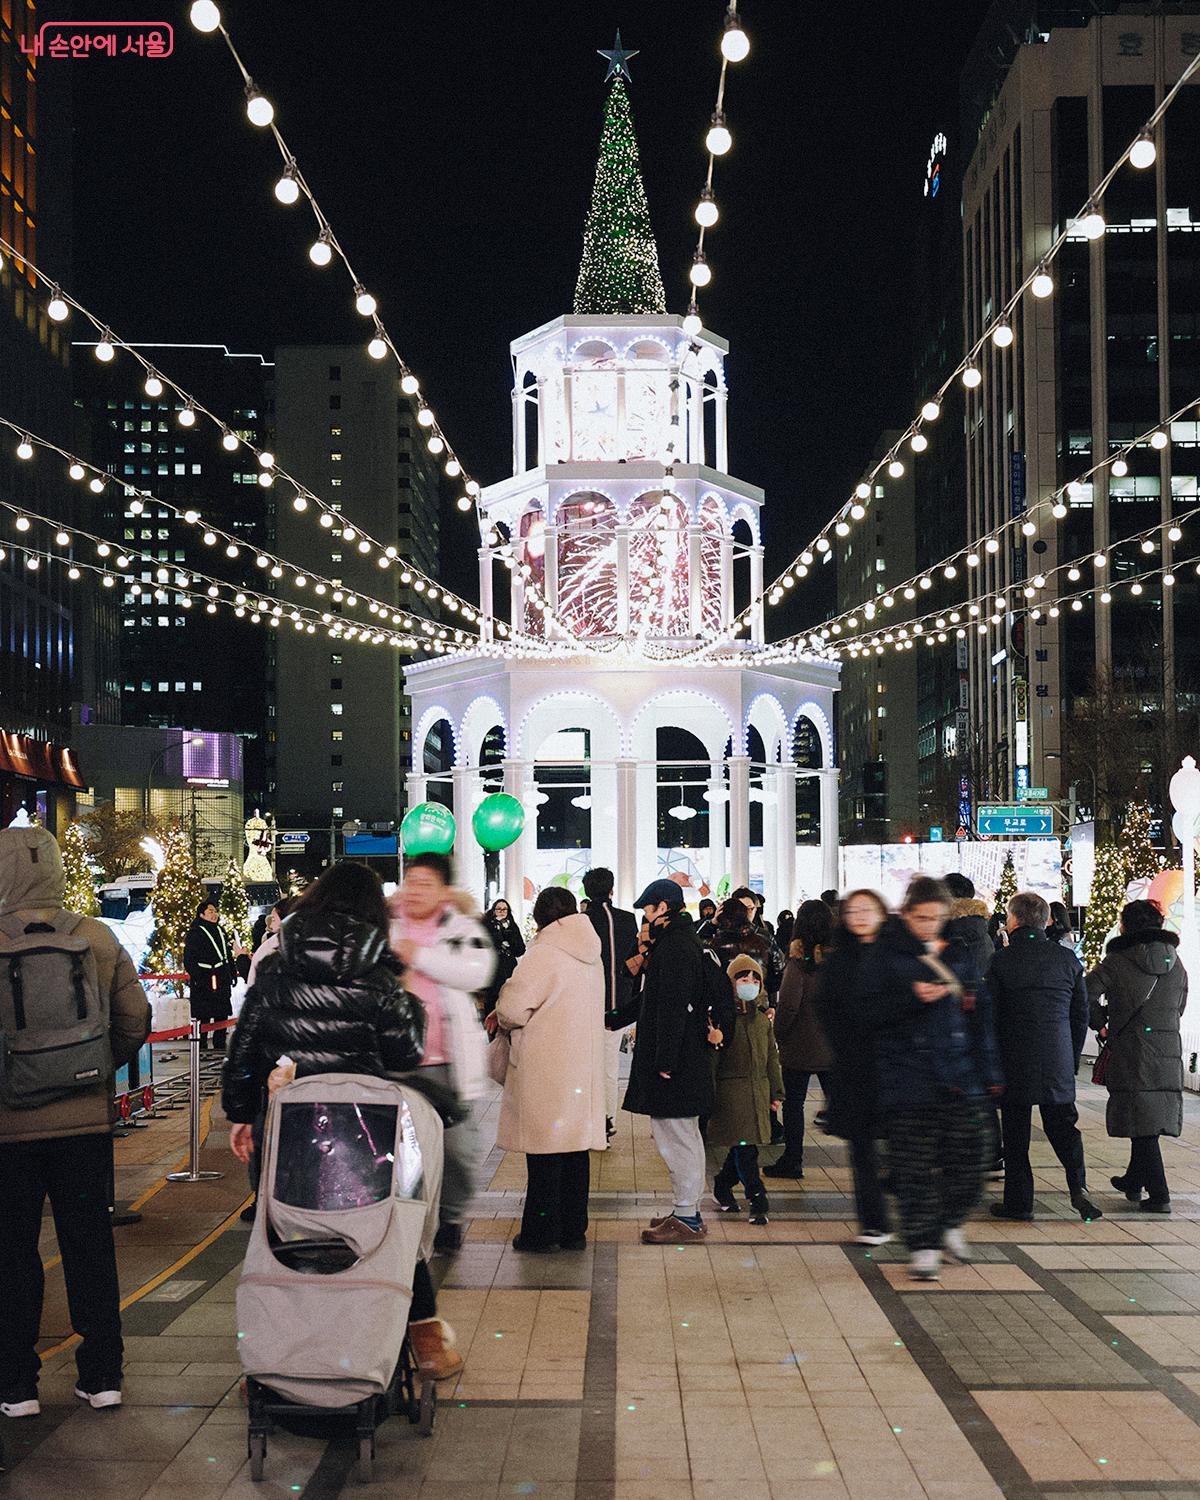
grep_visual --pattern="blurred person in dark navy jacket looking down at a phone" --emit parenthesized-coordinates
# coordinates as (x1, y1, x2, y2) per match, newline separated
(861, 876, 1002, 1281)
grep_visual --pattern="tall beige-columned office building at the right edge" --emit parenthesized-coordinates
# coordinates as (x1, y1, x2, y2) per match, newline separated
(963, 5, 1200, 813)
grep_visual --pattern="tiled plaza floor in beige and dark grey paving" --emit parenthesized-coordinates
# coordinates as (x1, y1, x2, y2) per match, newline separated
(0, 1062, 1200, 1500)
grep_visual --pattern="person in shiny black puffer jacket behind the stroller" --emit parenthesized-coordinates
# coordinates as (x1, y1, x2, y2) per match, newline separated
(221, 861, 462, 1380)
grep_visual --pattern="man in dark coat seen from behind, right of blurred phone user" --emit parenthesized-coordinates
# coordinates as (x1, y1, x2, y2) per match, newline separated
(987, 891, 1101, 1223)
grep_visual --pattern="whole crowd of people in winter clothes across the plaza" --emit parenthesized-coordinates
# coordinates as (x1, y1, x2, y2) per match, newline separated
(0, 828, 1187, 1418)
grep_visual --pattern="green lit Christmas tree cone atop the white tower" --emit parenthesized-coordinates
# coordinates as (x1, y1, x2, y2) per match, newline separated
(575, 74, 666, 317)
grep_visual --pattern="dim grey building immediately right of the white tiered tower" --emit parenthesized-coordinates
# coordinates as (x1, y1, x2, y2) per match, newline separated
(837, 432, 918, 843)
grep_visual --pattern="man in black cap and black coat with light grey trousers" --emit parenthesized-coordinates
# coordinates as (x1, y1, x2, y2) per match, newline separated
(608, 881, 714, 1245)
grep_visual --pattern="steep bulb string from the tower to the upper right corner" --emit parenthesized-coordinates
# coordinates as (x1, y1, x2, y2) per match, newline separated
(693, 53, 1200, 656)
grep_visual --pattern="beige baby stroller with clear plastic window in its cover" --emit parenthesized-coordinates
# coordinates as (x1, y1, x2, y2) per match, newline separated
(237, 1073, 443, 1481)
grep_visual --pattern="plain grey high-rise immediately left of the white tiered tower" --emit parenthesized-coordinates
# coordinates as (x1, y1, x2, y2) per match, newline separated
(276, 345, 441, 828)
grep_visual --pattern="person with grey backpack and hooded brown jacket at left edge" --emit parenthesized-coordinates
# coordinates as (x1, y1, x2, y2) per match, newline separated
(0, 828, 150, 1418)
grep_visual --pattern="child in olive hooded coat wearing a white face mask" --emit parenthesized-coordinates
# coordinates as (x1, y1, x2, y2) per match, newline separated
(707, 954, 783, 1224)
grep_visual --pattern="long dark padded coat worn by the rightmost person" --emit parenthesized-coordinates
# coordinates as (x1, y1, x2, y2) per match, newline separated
(1088, 930, 1188, 1137)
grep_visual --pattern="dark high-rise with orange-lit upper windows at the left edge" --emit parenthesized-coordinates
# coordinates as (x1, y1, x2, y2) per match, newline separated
(0, 0, 96, 828)
